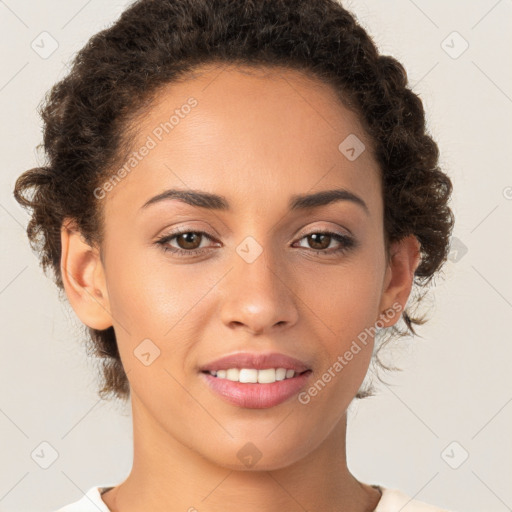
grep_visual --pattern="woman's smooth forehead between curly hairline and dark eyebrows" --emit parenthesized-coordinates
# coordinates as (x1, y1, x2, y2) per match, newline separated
(102, 61, 380, 218)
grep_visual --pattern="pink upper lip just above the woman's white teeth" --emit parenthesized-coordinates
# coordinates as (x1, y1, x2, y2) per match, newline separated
(200, 352, 309, 373)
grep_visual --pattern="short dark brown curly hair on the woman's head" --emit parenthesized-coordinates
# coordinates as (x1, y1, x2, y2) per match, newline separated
(14, 0, 454, 399)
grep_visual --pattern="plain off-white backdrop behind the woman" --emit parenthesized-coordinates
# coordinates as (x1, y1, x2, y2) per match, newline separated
(0, 0, 512, 512)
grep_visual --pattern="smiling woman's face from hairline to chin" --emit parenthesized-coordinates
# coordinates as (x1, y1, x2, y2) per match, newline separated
(63, 67, 420, 469)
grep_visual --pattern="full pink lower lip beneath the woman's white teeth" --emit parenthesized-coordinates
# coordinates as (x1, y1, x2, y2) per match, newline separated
(202, 370, 311, 409)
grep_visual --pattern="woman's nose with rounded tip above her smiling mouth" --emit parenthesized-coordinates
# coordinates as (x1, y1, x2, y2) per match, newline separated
(221, 250, 299, 334)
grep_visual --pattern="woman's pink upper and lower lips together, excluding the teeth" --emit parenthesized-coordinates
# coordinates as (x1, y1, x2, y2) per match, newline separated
(201, 352, 312, 409)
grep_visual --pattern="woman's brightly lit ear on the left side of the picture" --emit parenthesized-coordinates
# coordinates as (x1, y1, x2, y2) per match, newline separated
(60, 219, 112, 330)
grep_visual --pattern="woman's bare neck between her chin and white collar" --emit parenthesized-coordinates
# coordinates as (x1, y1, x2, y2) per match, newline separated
(102, 395, 380, 512)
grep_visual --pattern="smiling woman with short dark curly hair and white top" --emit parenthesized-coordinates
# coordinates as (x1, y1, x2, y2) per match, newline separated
(15, 0, 453, 512)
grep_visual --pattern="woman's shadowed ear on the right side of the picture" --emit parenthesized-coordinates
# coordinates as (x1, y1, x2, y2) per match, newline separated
(378, 235, 421, 327)
